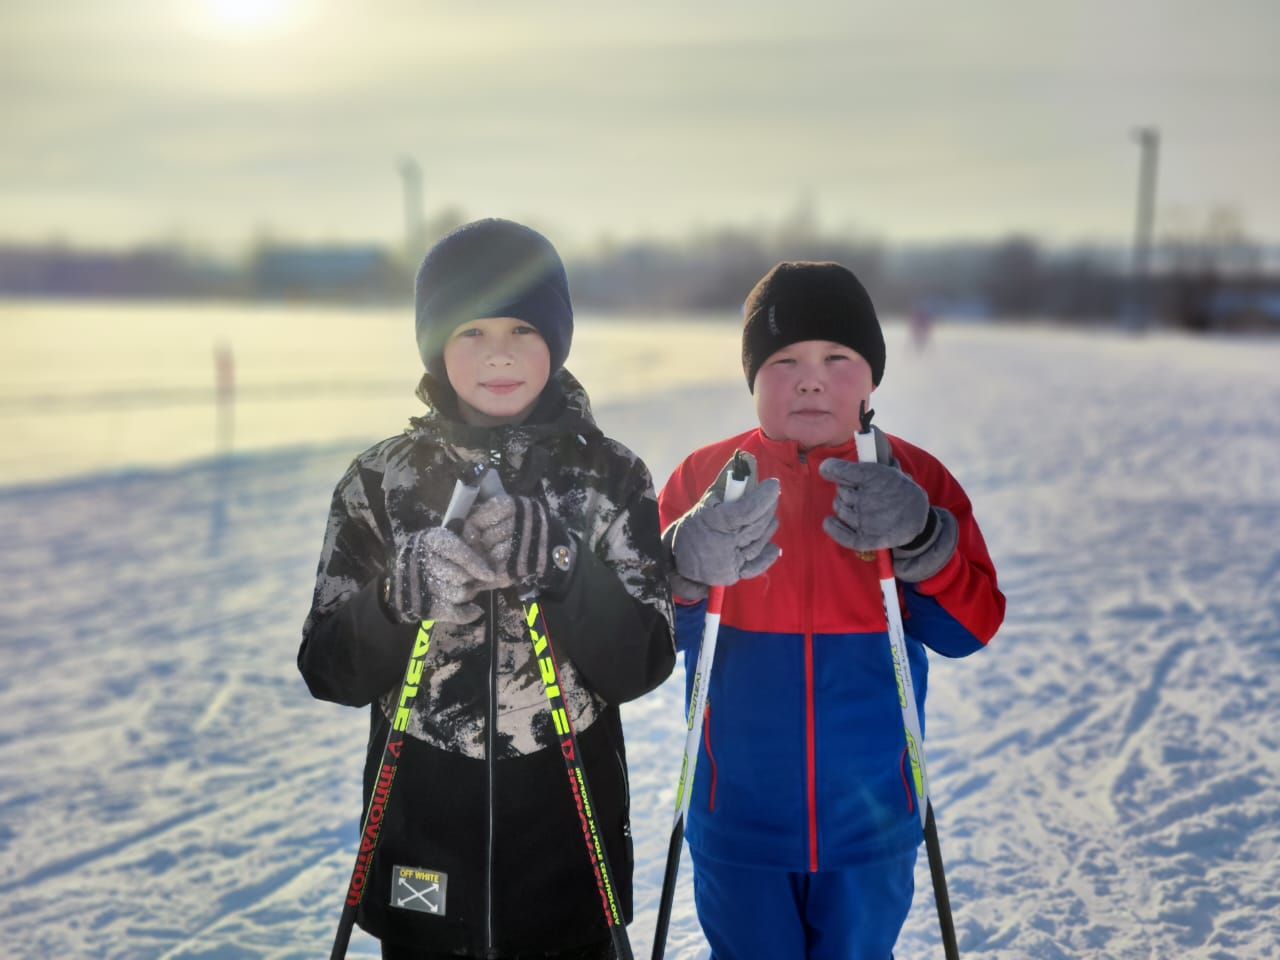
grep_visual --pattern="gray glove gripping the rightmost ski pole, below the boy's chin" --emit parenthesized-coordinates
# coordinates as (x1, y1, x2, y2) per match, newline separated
(818, 457, 959, 582)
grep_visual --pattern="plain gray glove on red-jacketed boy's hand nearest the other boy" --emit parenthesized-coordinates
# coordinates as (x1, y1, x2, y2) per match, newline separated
(662, 461, 782, 600)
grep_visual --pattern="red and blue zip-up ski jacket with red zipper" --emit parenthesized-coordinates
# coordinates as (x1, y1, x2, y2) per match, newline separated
(659, 429, 1005, 872)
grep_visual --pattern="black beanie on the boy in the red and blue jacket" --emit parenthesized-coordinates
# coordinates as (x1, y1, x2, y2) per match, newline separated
(742, 261, 884, 393)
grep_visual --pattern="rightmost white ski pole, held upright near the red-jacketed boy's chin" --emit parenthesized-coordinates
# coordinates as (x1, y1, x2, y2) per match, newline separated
(854, 401, 960, 960)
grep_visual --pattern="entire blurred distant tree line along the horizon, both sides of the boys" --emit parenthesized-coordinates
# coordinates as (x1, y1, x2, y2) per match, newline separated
(0, 218, 1280, 330)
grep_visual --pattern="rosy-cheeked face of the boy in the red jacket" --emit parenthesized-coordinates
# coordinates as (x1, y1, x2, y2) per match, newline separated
(755, 340, 874, 451)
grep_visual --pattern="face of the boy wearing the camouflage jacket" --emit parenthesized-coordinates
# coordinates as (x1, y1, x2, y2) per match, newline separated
(444, 316, 552, 426)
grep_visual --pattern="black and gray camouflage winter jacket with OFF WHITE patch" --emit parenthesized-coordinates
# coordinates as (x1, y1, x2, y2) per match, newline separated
(298, 371, 675, 956)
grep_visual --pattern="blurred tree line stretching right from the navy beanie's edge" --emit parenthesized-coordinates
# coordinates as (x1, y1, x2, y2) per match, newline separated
(570, 230, 1280, 332)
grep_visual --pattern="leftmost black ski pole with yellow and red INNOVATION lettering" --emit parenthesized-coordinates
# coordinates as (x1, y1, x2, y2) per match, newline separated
(329, 463, 485, 960)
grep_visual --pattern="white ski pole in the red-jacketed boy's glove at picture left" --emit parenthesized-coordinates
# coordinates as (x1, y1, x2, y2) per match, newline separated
(653, 451, 751, 960)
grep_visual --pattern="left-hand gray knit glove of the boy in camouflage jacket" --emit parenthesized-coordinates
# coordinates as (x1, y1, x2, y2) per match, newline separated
(383, 526, 499, 623)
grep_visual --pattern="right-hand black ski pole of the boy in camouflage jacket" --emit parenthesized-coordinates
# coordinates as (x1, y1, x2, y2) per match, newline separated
(522, 596, 634, 960)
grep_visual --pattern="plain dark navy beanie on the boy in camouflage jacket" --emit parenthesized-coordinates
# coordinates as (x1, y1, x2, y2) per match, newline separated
(413, 219, 573, 383)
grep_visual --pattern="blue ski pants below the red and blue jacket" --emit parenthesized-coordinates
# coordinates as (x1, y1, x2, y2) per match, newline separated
(694, 850, 915, 960)
